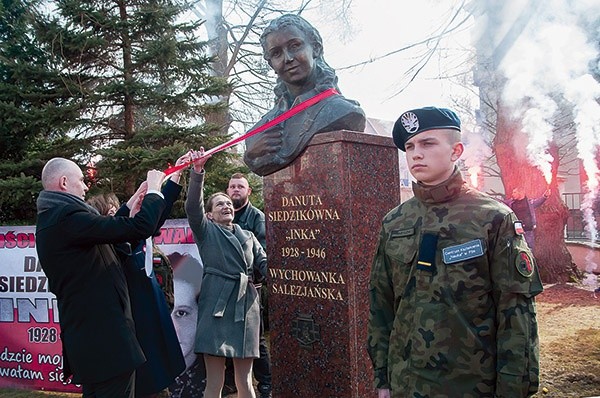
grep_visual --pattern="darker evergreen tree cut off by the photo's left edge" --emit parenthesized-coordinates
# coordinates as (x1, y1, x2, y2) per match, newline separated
(0, 0, 76, 225)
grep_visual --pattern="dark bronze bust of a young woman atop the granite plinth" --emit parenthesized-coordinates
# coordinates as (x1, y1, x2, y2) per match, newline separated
(244, 14, 366, 176)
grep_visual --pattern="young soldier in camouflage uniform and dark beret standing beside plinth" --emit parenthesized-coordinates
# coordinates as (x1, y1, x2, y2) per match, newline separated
(368, 107, 542, 398)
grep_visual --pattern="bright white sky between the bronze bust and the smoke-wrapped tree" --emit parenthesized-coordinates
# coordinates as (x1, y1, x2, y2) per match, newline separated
(305, 0, 473, 121)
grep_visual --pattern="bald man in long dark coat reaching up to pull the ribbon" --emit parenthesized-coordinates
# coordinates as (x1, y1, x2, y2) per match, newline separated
(36, 158, 165, 398)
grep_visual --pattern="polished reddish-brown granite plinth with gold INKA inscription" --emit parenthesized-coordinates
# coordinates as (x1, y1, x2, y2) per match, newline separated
(264, 131, 400, 398)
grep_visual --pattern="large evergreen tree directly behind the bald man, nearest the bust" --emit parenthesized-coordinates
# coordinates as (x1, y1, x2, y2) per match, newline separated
(38, 0, 227, 215)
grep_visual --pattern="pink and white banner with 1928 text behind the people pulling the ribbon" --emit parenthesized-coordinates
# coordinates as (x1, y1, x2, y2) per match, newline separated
(0, 219, 202, 392)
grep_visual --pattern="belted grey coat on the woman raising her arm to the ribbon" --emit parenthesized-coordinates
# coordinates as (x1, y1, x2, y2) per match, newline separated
(185, 170, 267, 358)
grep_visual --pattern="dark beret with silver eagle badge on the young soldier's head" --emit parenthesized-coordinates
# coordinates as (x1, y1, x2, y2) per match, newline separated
(392, 106, 460, 151)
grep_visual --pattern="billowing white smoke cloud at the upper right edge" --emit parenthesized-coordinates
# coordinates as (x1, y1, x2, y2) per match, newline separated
(500, 0, 600, 246)
